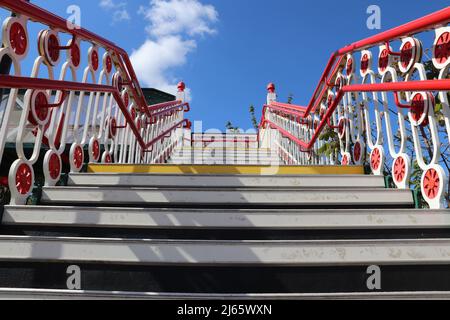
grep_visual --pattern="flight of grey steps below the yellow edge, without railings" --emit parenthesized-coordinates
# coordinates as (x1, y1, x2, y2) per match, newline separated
(0, 153, 450, 299)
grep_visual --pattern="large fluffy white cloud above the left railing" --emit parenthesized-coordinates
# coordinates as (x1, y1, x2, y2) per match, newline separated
(130, 0, 218, 99)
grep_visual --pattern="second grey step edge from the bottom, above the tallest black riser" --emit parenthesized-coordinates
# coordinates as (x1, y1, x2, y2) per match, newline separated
(0, 236, 450, 267)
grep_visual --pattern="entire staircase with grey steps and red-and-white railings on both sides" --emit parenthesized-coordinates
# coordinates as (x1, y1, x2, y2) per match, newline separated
(0, 0, 450, 299)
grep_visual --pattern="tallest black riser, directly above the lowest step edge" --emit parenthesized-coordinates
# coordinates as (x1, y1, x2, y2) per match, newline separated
(0, 262, 450, 294)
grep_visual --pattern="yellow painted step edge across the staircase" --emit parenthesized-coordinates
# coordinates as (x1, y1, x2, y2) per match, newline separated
(88, 164, 364, 175)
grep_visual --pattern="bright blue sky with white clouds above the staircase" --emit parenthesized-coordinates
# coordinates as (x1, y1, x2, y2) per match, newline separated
(6, 0, 448, 129)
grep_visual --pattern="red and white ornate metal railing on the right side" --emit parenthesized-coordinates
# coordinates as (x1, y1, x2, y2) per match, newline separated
(259, 7, 450, 208)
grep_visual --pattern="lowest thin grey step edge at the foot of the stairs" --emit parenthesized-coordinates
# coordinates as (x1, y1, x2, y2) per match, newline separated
(0, 288, 450, 301)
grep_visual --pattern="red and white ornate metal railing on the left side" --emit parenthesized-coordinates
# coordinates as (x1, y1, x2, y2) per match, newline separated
(0, 0, 190, 204)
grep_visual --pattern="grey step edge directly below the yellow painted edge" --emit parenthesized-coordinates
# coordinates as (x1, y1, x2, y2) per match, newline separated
(68, 173, 385, 189)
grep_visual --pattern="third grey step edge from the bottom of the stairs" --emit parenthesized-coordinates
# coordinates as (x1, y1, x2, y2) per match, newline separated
(2, 206, 450, 231)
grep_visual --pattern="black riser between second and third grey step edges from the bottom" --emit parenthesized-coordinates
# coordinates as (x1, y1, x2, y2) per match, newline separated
(2, 225, 450, 241)
